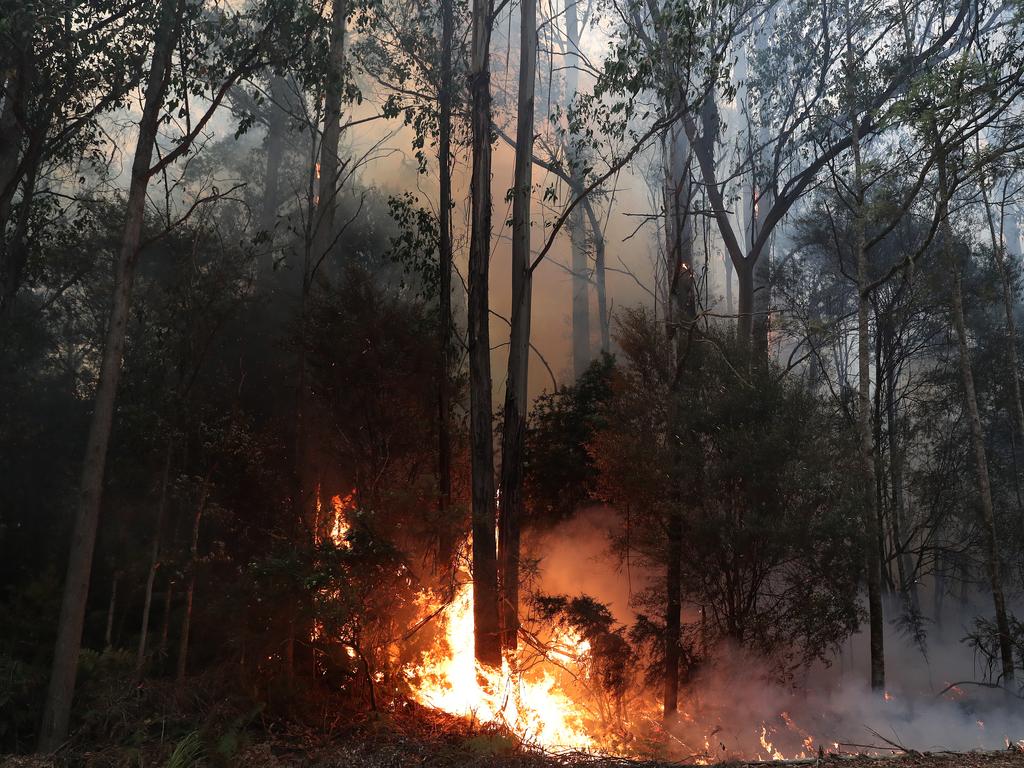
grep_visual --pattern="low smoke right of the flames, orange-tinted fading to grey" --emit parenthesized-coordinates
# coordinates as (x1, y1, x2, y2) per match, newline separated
(525, 507, 1024, 760)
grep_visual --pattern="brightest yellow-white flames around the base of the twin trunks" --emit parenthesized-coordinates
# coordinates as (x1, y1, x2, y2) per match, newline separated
(406, 584, 596, 750)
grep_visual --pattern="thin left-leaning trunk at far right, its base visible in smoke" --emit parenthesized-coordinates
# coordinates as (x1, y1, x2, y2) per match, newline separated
(936, 148, 1014, 687)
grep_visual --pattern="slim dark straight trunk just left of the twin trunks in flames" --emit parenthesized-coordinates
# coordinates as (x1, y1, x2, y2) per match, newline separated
(437, 0, 456, 567)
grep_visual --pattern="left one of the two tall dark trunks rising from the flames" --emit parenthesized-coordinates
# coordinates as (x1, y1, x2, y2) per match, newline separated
(469, 0, 502, 668)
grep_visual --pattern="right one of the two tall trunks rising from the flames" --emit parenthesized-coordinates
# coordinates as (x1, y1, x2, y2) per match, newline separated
(498, 0, 538, 650)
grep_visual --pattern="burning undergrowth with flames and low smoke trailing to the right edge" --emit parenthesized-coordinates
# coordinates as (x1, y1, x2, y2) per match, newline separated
(292, 493, 1024, 763)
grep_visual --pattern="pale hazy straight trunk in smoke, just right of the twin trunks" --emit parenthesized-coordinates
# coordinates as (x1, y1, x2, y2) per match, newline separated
(565, 0, 593, 379)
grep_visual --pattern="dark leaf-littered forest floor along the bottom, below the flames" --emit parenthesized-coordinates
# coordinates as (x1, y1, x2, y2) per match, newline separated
(0, 679, 1024, 768)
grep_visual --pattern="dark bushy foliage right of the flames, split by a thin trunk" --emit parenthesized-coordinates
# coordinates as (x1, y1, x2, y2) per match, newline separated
(592, 312, 859, 673)
